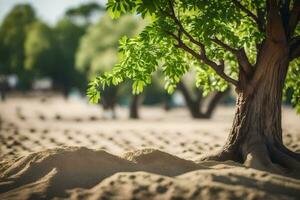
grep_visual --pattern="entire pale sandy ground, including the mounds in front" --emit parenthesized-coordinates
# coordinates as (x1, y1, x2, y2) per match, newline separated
(0, 97, 300, 200)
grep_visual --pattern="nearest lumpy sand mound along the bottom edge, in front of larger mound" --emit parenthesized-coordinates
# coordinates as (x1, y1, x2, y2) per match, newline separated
(69, 169, 299, 200)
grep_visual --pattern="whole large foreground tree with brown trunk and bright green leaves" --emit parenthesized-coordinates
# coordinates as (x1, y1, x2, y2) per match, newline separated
(87, 0, 300, 173)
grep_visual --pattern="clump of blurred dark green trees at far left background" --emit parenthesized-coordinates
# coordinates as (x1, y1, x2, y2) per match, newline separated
(0, 4, 99, 92)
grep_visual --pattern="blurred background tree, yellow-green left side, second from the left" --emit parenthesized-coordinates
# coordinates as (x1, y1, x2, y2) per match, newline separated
(24, 19, 84, 91)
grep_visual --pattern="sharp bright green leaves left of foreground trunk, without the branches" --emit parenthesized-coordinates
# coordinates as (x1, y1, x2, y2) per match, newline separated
(89, 1, 258, 101)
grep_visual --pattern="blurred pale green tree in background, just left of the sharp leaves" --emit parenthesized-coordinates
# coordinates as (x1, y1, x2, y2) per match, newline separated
(76, 15, 141, 117)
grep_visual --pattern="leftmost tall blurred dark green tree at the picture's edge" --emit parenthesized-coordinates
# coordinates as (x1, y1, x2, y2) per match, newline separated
(0, 4, 36, 88)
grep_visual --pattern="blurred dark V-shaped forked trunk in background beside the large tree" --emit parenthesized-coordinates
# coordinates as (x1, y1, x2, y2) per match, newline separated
(178, 81, 229, 119)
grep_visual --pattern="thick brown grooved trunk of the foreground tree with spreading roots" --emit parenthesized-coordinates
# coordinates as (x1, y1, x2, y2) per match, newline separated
(203, 41, 300, 173)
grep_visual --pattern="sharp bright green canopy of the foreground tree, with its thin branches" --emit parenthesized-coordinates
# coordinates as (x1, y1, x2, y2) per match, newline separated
(87, 0, 299, 112)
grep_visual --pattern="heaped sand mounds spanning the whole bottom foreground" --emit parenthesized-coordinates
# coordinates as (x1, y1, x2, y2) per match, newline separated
(0, 147, 300, 200)
